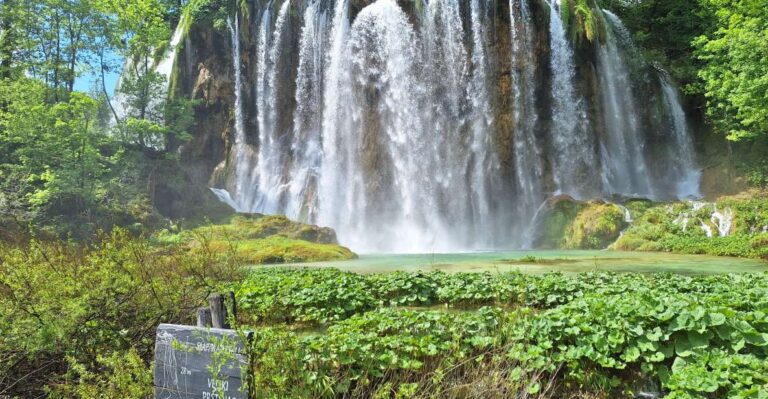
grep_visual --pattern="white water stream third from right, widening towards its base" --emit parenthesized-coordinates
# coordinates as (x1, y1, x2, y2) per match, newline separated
(549, 0, 599, 199)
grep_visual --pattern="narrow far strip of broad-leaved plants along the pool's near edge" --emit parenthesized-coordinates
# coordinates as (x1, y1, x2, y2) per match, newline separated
(237, 268, 586, 325)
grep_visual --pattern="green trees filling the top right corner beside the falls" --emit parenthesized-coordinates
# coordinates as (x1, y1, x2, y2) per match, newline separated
(601, 0, 768, 145)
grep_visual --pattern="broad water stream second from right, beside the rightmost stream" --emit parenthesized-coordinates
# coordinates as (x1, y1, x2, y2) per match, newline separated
(598, 10, 655, 198)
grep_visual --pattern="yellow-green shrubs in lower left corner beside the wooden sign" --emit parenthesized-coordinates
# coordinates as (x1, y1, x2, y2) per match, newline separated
(0, 231, 240, 398)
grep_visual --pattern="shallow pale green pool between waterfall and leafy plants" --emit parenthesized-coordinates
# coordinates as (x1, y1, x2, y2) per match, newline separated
(284, 250, 768, 274)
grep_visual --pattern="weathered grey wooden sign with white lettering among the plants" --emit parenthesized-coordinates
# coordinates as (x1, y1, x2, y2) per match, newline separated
(155, 324, 251, 399)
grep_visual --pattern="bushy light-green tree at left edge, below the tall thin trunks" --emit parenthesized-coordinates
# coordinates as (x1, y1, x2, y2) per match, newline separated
(0, 78, 109, 236)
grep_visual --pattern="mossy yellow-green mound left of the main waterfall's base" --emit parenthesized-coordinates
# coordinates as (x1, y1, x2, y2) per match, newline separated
(158, 213, 357, 264)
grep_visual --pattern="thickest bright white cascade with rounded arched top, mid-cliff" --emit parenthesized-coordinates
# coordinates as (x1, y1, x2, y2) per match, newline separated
(342, 0, 440, 251)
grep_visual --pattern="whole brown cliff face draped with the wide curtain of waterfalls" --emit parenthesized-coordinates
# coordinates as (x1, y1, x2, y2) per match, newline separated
(176, 0, 699, 251)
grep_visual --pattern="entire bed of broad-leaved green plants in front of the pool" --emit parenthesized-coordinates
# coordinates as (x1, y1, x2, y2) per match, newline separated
(239, 269, 768, 398)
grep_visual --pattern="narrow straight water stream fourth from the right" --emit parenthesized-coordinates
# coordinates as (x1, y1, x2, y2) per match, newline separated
(509, 0, 544, 241)
